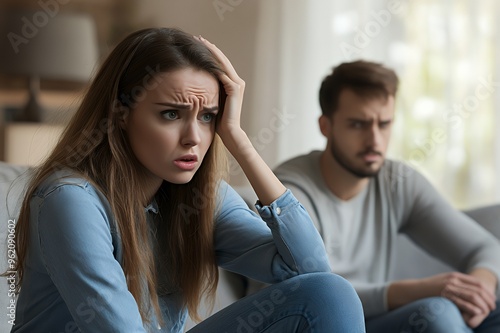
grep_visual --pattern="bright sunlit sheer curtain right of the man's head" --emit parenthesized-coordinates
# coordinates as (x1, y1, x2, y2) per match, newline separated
(391, 0, 500, 208)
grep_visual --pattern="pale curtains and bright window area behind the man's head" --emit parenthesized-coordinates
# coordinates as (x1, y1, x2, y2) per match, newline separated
(245, 0, 500, 208)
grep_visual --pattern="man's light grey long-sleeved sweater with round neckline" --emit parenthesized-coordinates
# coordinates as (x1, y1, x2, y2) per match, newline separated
(275, 151, 500, 317)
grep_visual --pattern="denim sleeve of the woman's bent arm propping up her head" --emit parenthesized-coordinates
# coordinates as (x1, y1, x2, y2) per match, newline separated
(215, 183, 330, 283)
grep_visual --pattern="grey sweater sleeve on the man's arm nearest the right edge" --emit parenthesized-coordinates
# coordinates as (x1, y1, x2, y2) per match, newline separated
(401, 167, 500, 281)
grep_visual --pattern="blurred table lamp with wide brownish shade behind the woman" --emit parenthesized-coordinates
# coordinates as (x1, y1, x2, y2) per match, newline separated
(0, 10, 98, 121)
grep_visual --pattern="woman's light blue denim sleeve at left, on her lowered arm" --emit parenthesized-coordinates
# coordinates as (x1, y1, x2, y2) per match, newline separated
(35, 185, 145, 332)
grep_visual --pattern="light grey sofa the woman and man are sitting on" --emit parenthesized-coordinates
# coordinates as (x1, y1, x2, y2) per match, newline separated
(0, 162, 500, 332)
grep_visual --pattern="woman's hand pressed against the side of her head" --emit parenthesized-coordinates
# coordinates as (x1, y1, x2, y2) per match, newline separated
(195, 36, 245, 146)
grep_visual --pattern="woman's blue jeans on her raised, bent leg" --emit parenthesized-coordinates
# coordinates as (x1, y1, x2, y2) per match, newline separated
(188, 273, 365, 333)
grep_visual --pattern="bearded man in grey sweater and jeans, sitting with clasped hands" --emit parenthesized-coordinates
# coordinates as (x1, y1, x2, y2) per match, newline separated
(275, 61, 500, 333)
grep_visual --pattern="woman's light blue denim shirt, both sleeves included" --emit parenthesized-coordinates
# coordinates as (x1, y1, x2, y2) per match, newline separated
(12, 173, 330, 333)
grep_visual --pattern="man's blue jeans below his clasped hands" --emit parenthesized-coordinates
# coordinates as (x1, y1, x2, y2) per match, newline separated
(366, 297, 500, 333)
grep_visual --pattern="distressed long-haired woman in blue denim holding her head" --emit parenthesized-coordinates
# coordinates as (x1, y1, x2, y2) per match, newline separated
(12, 28, 364, 333)
